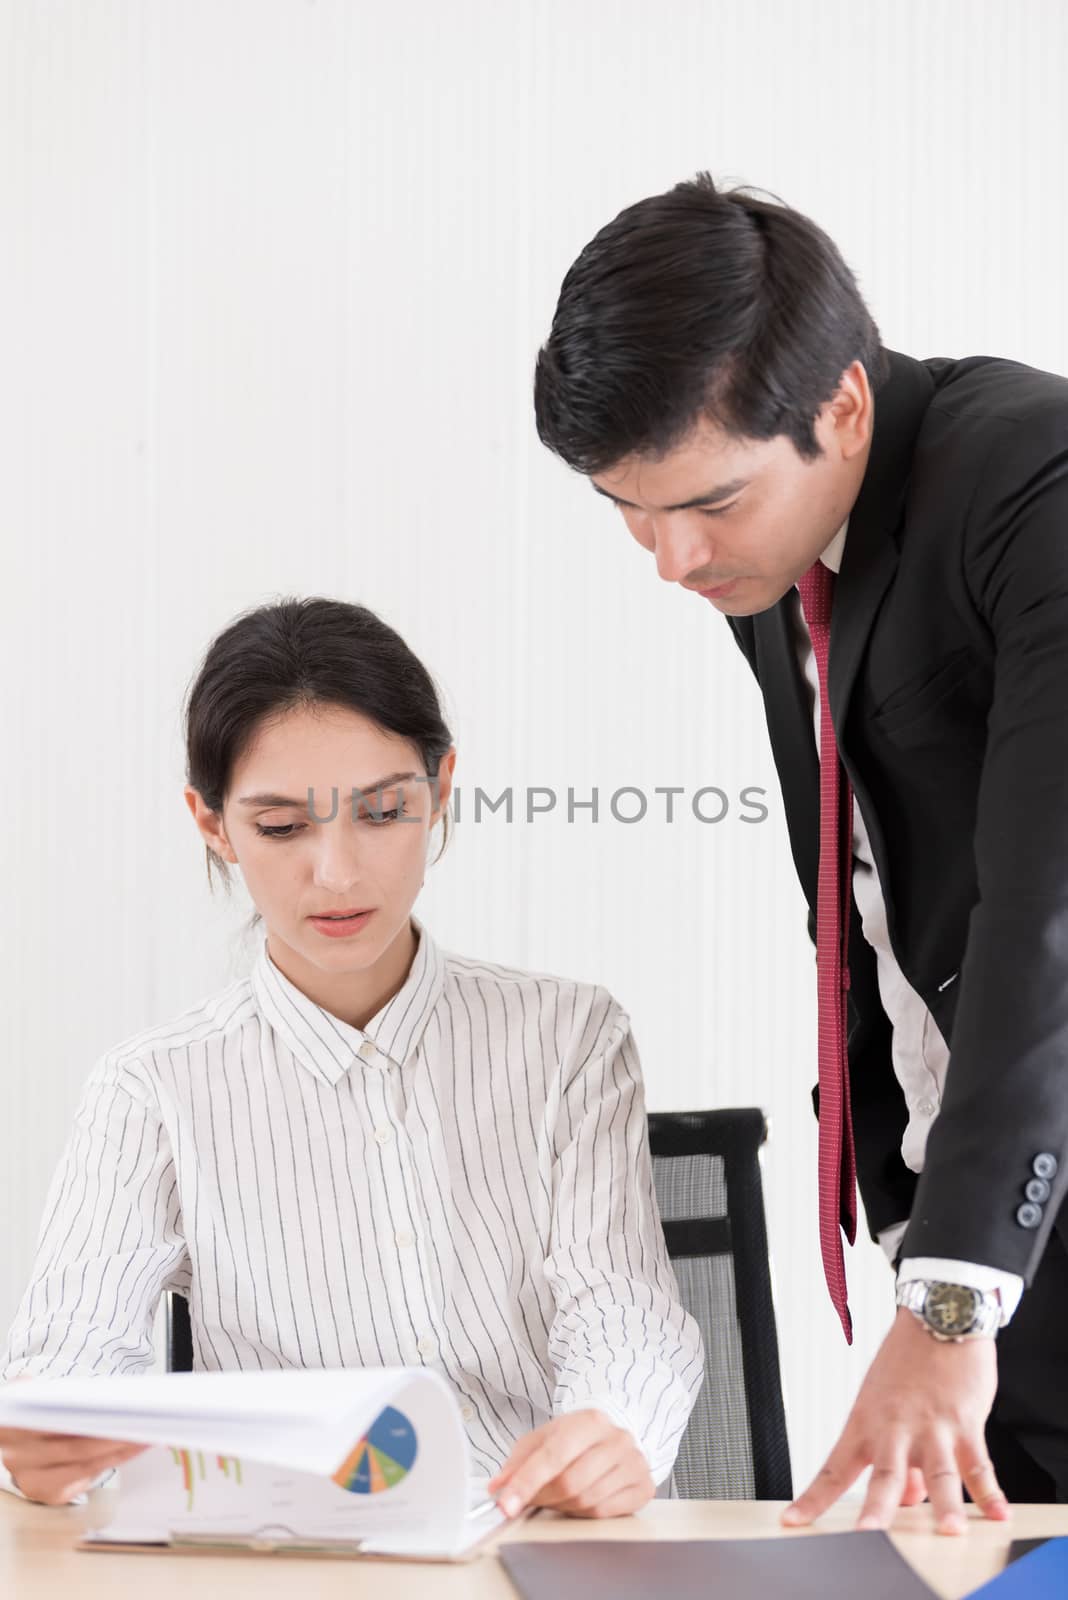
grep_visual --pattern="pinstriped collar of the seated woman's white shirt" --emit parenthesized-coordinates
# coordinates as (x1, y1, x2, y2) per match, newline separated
(251, 917, 444, 1085)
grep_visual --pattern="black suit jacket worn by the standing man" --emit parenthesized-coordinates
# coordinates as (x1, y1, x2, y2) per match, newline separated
(729, 350, 1068, 1282)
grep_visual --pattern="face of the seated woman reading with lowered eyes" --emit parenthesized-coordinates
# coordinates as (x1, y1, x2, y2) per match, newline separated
(185, 706, 456, 973)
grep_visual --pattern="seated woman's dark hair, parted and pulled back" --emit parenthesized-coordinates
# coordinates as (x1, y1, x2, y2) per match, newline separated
(184, 597, 452, 920)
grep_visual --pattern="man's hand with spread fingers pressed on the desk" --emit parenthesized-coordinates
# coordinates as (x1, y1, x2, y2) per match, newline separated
(782, 1307, 1009, 1533)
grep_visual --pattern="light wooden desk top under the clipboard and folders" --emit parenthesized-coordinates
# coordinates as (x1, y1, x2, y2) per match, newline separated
(0, 1488, 1068, 1600)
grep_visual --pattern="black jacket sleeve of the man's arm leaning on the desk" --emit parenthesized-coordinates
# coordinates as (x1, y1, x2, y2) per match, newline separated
(902, 408, 1068, 1282)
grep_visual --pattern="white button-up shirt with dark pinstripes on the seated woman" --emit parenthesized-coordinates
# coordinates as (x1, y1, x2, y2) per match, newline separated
(0, 918, 703, 1482)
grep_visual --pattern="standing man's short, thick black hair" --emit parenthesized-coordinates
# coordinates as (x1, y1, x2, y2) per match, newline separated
(534, 173, 889, 475)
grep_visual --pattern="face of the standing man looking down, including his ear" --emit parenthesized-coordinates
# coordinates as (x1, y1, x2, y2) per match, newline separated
(590, 362, 873, 616)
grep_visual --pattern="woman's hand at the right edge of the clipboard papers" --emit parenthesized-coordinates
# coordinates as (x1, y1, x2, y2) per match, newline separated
(489, 1411, 654, 1517)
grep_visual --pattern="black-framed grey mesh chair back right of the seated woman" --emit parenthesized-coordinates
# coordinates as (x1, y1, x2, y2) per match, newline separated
(649, 1109, 793, 1499)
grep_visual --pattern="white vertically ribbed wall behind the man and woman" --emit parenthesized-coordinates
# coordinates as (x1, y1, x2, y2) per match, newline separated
(0, 0, 1068, 1485)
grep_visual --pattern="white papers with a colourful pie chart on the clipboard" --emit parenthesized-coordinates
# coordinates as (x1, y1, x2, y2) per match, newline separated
(0, 1366, 504, 1560)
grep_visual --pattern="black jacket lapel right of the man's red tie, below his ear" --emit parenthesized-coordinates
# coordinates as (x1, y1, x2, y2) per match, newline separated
(828, 350, 934, 742)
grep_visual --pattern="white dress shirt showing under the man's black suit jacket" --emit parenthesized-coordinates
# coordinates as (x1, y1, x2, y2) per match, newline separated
(795, 517, 1023, 1325)
